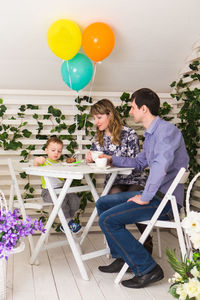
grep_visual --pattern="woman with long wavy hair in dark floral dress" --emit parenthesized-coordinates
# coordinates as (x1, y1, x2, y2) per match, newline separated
(86, 99, 153, 253)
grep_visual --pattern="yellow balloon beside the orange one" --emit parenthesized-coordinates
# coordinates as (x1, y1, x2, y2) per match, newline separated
(47, 19, 82, 60)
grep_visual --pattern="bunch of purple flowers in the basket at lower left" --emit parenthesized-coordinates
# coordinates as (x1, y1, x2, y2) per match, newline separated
(0, 208, 45, 260)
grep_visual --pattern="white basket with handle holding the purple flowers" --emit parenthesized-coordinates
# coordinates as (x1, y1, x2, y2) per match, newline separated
(0, 191, 25, 300)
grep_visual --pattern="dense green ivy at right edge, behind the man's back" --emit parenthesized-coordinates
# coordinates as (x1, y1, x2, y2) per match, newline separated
(171, 61, 200, 180)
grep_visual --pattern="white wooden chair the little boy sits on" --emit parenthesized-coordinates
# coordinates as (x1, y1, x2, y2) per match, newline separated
(8, 159, 53, 252)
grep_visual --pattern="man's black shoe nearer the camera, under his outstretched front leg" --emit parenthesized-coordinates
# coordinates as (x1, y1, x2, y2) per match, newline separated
(122, 265, 164, 289)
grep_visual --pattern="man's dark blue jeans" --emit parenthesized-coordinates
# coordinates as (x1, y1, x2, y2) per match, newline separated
(96, 191, 175, 276)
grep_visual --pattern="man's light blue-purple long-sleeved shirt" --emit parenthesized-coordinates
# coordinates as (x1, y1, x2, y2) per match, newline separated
(112, 117, 189, 205)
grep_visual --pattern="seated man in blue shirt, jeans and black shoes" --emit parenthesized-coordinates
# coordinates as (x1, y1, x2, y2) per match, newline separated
(96, 88, 189, 288)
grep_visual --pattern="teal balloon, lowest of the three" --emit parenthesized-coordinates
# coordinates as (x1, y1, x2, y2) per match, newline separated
(61, 53, 93, 91)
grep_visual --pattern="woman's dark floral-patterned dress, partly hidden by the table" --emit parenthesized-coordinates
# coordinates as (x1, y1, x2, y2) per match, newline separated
(90, 126, 147, 186)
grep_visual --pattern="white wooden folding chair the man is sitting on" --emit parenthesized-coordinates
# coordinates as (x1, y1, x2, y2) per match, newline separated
(115, 168, 188, 284)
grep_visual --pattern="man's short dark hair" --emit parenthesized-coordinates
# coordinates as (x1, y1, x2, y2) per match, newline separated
(131, 88, 160, 116)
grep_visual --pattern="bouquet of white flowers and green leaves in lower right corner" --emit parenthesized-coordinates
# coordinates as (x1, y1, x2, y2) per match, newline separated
(166, 211, 200, 300)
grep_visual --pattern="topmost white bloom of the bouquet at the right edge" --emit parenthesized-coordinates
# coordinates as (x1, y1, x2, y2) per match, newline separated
(181, 211, 200, 235)
